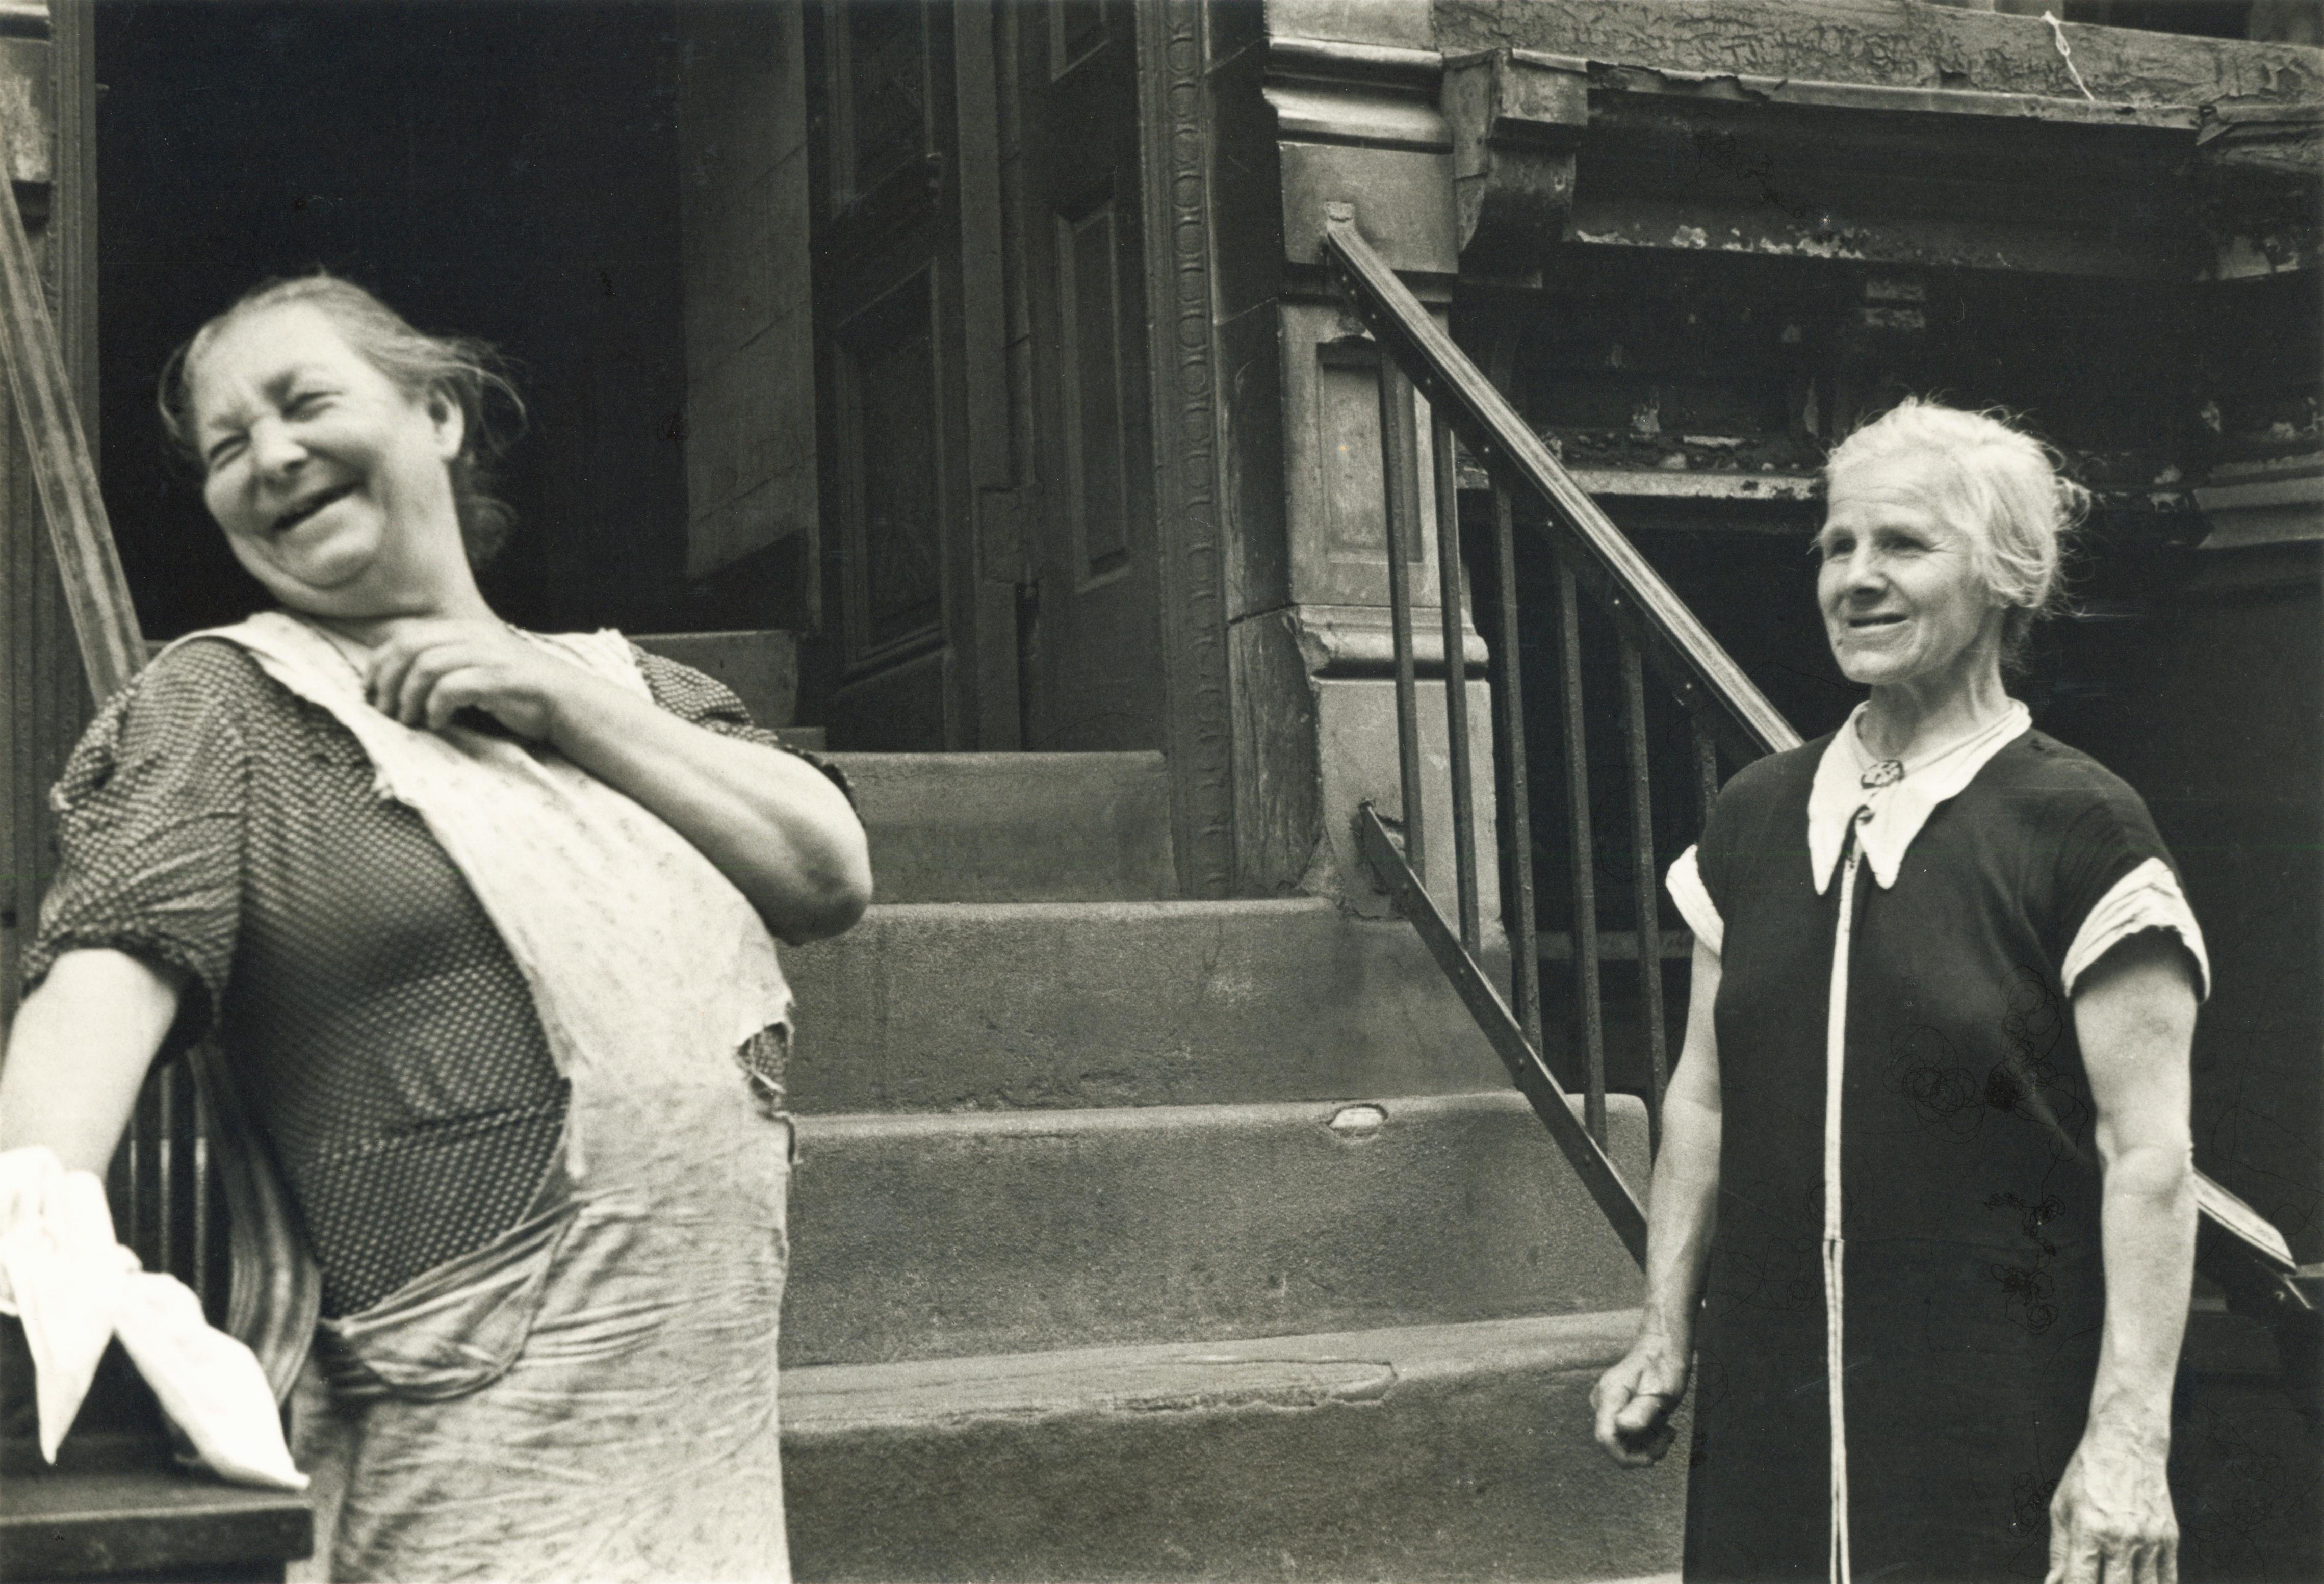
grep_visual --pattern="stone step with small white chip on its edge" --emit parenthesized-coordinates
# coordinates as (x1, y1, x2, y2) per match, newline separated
(783, 1089, 1648, 1366)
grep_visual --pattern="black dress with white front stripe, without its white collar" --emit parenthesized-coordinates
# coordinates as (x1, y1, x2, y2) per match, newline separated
(1685, 732, 2168, 1584)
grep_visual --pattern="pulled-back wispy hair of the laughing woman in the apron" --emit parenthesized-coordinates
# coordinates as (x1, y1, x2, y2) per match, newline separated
(158, 269, 525, 567)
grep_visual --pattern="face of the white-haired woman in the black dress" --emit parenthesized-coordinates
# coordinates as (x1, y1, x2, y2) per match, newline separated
(1815, 460, 2003, 687)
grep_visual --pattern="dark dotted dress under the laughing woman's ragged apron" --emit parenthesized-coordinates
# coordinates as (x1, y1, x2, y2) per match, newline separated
(25, 639, 844, 1317)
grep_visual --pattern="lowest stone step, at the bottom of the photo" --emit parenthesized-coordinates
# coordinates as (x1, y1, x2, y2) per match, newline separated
(783, 1312, 1687, 1584)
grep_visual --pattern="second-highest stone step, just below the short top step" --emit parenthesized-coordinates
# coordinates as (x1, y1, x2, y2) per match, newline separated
(783, 897, 1506, 1112)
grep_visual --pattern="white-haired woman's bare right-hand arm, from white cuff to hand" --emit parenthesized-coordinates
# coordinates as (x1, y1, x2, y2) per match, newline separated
(2050, 931, 2196, 1584)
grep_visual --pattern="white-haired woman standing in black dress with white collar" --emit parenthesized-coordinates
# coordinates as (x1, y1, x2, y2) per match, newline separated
(1594, 400, 2210, 1584)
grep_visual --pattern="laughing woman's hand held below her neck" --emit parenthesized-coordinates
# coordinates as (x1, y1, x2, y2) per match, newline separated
(363, 618, 597, 741)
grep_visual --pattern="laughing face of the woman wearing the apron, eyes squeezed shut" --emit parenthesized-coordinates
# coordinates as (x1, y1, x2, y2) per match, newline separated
(193, 302, 465, 618)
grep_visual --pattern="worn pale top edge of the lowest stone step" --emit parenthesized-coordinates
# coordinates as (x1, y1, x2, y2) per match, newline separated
(781, 1310, 1638, 1445)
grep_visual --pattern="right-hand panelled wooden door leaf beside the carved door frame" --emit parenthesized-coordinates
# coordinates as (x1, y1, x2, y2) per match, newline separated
(1001, 0, 1165, 750)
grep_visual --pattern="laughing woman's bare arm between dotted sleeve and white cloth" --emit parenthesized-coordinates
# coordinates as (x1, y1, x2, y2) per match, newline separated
(0, 950, 182, 1173)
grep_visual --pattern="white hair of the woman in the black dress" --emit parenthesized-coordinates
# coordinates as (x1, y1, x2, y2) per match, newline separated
(1824, 397, 2089, 666)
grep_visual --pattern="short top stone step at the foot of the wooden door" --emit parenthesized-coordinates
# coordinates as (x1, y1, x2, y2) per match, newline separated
(830, 752, 1178, 901)
